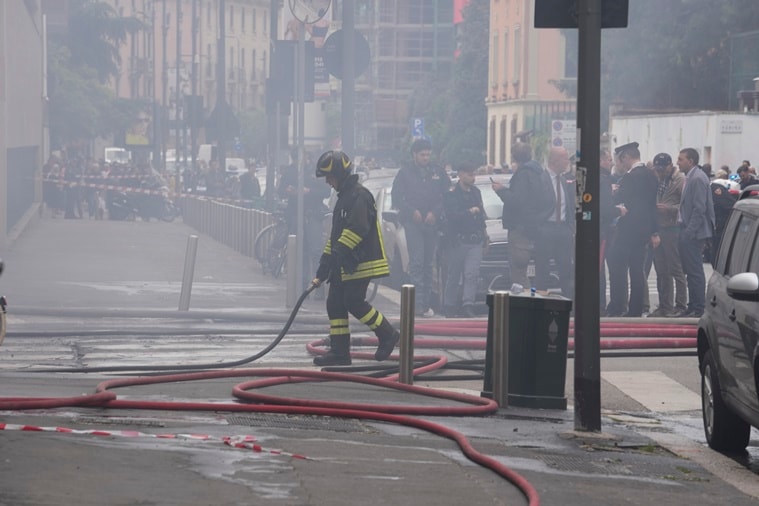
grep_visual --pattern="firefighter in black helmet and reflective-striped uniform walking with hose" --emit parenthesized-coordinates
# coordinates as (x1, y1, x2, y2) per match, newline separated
(312, 151, 400, 366)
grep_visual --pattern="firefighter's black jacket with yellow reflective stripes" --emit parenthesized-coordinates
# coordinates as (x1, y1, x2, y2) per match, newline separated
(316, 174, 390, 281)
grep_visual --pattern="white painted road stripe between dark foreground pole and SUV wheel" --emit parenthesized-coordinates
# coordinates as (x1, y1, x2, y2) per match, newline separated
(601, 371, 701, 412)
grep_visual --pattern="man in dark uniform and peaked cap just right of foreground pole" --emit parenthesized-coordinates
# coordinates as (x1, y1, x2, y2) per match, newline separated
(608, 142, 659, 317)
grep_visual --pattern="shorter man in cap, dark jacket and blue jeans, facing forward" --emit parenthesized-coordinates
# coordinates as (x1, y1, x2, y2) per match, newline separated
(443, 164, 488, 318)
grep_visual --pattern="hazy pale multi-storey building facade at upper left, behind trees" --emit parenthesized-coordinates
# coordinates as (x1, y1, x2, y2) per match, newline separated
(108, 0, 271, 158)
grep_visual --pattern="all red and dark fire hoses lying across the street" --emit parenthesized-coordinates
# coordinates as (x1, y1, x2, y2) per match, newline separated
(0, 286, 695, 506)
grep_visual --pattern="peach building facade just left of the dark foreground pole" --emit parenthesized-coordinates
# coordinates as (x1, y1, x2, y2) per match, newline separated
(485, 0, 577, 166)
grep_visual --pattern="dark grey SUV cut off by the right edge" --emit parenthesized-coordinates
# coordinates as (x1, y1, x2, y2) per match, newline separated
(698, 186, 759, 452)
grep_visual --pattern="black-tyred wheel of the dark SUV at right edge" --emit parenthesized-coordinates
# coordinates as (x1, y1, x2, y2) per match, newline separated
(701, 350, 751, 452)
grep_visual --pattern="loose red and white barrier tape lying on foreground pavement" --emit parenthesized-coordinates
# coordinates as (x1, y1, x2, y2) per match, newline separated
(0, 423, 312, 460)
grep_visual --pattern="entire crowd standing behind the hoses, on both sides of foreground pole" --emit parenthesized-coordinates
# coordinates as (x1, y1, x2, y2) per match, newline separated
(378, 139, 759, 317)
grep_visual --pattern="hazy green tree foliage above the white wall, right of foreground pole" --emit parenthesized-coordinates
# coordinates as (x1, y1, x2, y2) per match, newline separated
(601, 0, 759, 117)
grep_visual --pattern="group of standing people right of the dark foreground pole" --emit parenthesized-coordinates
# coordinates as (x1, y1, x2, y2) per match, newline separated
(600, 142, 757, 317)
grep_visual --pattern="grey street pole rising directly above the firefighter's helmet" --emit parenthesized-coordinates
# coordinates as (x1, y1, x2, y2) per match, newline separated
(341, 0, 356, 154)
